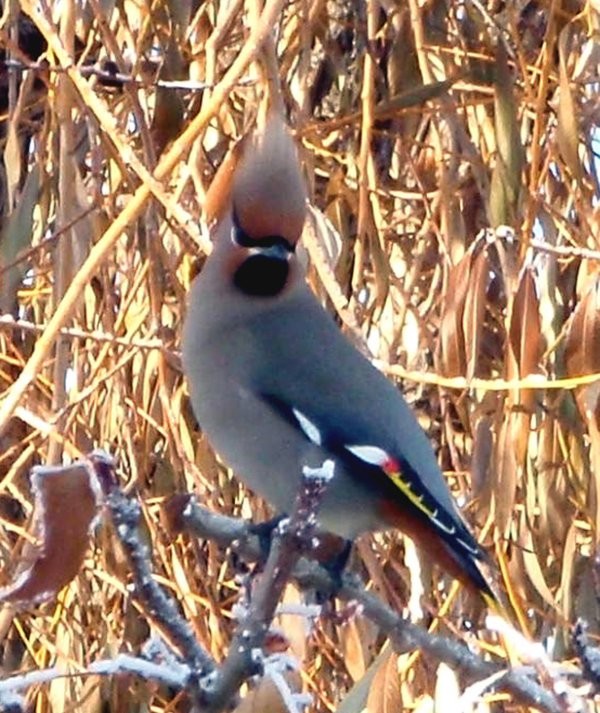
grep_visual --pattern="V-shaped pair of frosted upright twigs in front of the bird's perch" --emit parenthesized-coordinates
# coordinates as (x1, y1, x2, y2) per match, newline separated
(96, 457, 333, 711)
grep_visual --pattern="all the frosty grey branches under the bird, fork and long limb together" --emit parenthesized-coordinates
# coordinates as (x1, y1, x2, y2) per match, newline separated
(0, 453, 584, 713)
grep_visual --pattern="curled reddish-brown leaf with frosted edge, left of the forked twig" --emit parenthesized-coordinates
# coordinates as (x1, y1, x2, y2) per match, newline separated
(0, 462, 100, 605)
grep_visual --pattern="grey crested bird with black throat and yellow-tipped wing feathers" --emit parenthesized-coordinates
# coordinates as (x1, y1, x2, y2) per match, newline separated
(182, 115, 496, 604)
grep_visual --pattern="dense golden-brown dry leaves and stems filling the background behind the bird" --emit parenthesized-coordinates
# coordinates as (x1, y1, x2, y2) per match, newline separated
(0, 0, 600, 712)
